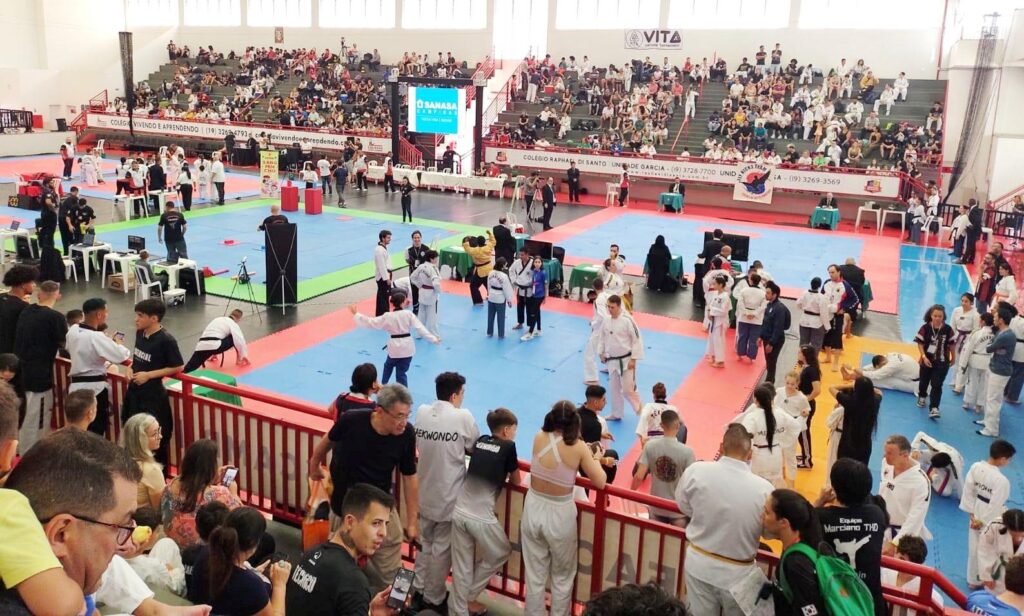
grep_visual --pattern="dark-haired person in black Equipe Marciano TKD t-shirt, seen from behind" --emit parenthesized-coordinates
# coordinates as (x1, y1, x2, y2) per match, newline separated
(814, 457, 888, 616)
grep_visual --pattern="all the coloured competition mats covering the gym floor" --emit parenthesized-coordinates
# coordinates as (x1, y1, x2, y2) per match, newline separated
(0, 146, 999, 588)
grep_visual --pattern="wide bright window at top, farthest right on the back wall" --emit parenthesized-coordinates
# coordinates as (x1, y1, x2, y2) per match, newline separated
(799, 0, 945, 30)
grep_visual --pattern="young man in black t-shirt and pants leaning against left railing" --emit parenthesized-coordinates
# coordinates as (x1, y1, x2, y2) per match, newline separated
(121, 299, 185, 469)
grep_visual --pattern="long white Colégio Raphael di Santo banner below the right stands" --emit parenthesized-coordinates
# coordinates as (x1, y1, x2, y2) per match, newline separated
(484, 145, 900, 200)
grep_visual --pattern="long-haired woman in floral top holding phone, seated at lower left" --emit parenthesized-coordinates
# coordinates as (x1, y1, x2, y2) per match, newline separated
(160, 439, 242, 549)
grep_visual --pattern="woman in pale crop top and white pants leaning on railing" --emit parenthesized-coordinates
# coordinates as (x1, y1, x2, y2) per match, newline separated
(520, 400, 607, 616)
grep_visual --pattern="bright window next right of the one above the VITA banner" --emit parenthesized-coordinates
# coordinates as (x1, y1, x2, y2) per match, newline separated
(668, 0, 786, 30)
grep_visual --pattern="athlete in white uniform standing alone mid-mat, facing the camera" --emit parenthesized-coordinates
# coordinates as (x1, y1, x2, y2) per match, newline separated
(597, 296, 644, 420)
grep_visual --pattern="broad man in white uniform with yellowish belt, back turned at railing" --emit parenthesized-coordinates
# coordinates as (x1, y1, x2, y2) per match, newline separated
(675, 424, 773, 616)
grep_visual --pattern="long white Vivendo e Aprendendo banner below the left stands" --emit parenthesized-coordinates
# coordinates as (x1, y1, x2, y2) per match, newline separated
(86, 113, 391, 153)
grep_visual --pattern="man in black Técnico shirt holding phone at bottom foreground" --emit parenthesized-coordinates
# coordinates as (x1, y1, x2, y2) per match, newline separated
(285, 483, 398, 616)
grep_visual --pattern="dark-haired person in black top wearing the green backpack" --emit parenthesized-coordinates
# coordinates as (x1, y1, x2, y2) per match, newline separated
(763, 490, 831, 616)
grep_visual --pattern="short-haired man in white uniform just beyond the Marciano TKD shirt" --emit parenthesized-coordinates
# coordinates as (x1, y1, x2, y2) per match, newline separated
(879, 435, 932, 556)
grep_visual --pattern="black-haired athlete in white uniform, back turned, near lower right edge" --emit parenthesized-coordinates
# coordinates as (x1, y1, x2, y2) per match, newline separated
(961, 439, 1017, 586)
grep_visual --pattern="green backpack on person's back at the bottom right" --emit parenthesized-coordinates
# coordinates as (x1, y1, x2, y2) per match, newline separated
(778, 542, 874, 616)
